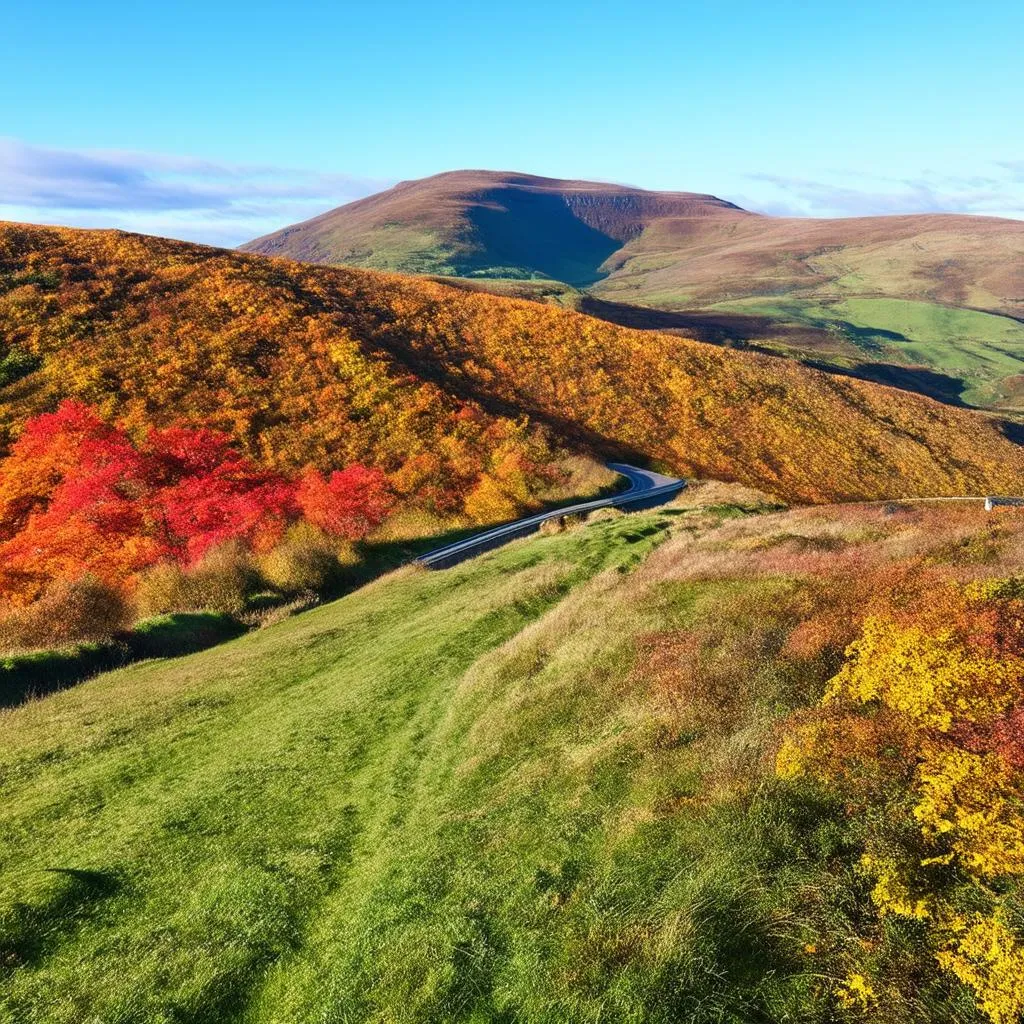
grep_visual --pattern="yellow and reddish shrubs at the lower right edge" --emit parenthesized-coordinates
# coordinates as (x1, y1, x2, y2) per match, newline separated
(778, 579, 1024, 1024)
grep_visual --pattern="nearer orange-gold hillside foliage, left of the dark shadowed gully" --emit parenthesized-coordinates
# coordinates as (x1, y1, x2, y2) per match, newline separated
(0, 225, 556, 520)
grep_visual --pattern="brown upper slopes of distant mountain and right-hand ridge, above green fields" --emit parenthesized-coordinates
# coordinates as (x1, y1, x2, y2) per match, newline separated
(242, 171, 1024, 315)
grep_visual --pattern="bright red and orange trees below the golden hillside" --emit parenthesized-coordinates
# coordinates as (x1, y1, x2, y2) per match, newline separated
(0, 400, 393, 605)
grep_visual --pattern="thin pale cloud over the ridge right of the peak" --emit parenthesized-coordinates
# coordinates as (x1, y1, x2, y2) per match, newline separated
(741, 161, 1024, 218)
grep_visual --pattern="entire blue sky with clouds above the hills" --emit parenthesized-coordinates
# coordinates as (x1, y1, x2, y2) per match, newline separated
(0, 0, 1024, 245)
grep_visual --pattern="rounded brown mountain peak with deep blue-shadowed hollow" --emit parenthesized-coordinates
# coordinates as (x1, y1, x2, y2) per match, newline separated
(242, 171, 742, 287)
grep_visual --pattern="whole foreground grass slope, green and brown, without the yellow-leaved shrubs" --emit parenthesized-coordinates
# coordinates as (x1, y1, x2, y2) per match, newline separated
(6, 495, 1024, 1024)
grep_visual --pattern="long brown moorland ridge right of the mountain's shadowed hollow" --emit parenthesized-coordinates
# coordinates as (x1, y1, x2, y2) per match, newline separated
(595, 208, 1024, 315)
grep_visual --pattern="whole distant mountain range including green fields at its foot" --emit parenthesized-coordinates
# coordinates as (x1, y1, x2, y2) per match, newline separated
(243, 171, 1024, 411)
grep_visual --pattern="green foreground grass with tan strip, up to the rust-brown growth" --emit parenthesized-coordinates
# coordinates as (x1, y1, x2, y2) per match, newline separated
(0, 503, 823, 1024)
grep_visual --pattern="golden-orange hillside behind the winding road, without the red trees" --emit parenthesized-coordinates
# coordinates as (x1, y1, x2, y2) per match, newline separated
(0, 225, 1024, 502)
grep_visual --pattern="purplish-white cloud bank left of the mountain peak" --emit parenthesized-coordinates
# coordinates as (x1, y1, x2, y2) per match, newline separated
(0, 138, 392, 245)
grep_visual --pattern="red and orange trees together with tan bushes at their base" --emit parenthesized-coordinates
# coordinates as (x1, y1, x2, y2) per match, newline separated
(0, 401, 393, 648)
